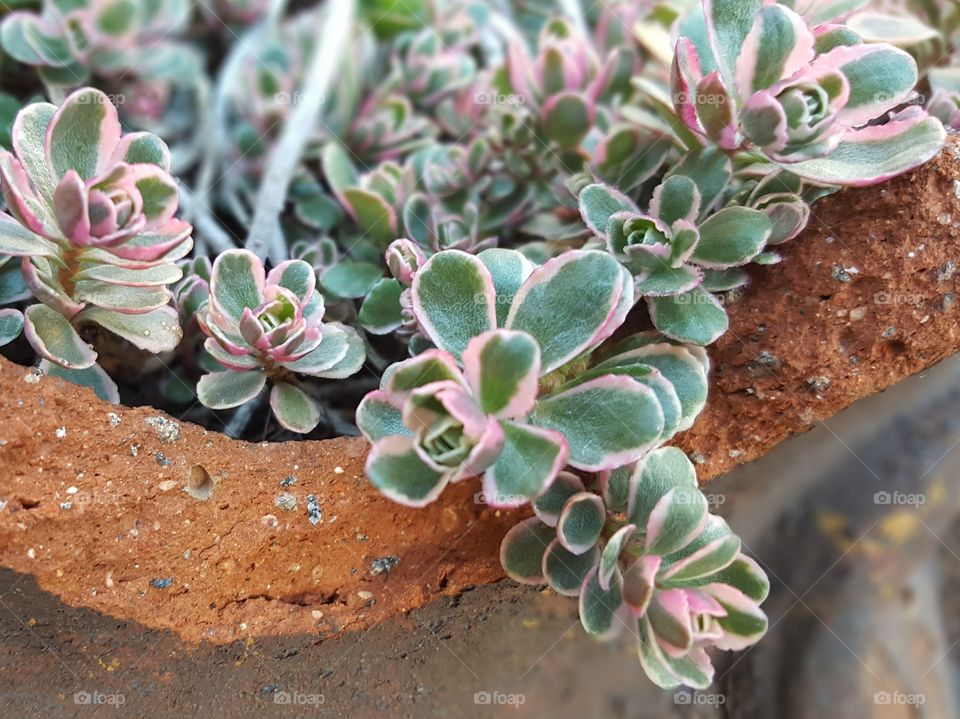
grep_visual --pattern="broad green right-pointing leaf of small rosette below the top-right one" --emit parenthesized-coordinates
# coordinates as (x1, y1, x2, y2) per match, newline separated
(691, 207, 773, 269)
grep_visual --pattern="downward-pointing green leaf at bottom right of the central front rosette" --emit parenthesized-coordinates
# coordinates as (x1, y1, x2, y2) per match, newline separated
(483, 420, 567, 507)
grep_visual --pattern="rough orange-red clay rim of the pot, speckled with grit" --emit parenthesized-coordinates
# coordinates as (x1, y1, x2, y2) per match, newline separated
(0, 141, 960, 644)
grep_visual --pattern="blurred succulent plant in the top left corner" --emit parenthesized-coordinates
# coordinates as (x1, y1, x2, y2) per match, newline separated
(0, 0, 200, 87)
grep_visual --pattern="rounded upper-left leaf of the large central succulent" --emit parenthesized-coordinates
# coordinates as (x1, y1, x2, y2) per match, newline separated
(412, 250, 496, 360)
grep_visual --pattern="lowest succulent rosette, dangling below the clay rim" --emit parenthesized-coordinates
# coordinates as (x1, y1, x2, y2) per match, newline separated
(500, 447, 769, 689)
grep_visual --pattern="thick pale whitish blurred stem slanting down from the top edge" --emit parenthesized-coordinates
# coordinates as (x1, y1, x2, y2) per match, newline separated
(246, 0, 356, 262)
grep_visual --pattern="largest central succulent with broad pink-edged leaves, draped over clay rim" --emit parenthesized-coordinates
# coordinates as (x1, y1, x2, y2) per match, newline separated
(357, 249, 706, 506)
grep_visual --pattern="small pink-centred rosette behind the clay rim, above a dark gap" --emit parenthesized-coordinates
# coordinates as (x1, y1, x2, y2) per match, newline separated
(197, 250, 366, 433)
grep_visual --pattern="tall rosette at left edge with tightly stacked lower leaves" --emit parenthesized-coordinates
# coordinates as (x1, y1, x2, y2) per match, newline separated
(0, 88, 193, 397)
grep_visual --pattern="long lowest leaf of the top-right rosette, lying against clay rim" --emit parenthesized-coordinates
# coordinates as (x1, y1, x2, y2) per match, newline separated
(784, 117, 946, 187)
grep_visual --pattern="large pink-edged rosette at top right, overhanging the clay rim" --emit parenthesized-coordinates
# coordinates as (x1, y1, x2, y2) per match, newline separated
(672, 0, 945, 185)
